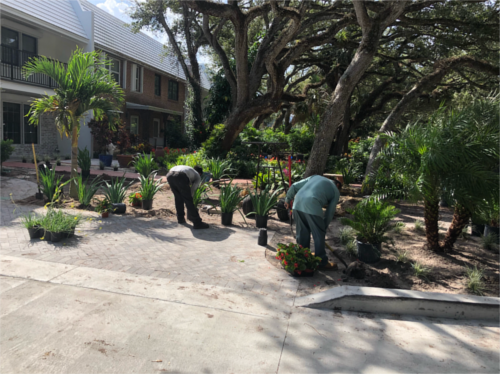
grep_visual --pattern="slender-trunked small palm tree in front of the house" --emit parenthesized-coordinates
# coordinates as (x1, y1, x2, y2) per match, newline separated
(24, 49, 124, 198)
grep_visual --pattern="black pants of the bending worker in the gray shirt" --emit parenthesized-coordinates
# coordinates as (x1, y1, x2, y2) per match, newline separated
(167, 171, 201, 225)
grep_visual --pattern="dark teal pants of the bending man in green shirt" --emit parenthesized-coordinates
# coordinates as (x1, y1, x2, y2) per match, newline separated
(293, 210, 328, 265)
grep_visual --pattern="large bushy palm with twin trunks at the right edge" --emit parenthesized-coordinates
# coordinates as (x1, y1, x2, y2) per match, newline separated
(376, 96, 500, 251)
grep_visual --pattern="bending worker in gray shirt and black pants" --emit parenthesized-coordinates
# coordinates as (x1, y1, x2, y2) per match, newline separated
(167, 165, 209, 229)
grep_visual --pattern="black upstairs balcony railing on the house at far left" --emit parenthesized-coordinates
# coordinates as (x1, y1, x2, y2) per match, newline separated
(0, 44, 64, 88)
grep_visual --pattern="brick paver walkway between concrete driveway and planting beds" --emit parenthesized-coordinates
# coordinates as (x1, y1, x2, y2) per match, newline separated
(0, 177, 298, 296)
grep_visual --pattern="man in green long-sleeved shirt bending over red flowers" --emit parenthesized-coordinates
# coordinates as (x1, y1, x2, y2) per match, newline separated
(285, 175, 340, 270)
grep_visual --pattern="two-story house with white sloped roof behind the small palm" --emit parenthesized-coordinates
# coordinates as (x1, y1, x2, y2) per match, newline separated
(0, 0, 208, 157)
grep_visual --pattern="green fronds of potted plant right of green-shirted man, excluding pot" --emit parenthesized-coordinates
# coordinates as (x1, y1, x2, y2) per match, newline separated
(341, 198, 400, 244)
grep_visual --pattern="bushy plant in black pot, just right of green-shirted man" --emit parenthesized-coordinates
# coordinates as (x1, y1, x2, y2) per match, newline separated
(341, 198, 400, 263)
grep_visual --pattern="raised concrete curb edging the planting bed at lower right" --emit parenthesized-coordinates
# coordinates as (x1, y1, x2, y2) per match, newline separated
(295, 286, 500, 321)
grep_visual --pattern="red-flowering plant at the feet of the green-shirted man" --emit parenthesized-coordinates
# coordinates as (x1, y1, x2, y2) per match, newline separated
(276, 243, 321, 275)
